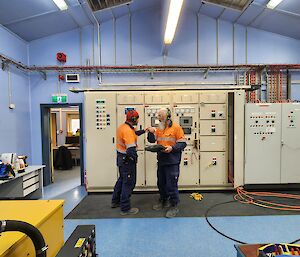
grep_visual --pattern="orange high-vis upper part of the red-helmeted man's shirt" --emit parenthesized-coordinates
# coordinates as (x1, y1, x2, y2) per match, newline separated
(117, 123, 138, 154)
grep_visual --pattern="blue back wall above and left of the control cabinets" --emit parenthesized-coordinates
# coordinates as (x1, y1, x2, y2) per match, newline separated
(25, 8, 300, 164)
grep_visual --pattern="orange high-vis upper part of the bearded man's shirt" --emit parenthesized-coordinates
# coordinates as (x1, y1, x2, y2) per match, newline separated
(155, 123, 186, 146)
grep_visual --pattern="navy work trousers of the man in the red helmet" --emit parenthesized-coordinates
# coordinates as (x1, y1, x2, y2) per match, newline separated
(112, 163, 136, 211)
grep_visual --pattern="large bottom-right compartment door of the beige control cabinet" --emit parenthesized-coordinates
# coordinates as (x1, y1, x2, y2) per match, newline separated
(200, 152, 228, 186)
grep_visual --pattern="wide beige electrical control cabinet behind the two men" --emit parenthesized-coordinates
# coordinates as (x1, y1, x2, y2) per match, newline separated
(85, 90, 230, 192)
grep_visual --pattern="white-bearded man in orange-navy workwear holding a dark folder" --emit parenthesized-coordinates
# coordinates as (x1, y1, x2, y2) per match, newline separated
(148, 108, 186, 218)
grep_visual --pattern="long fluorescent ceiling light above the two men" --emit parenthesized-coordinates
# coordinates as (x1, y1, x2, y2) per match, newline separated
(164, 0, 183, 44)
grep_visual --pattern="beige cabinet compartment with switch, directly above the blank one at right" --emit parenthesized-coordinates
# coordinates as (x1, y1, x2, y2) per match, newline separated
(200, 120, 227, 136)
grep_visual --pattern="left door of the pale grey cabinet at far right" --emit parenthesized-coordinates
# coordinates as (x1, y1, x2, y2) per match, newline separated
(245, 103, 281, 184)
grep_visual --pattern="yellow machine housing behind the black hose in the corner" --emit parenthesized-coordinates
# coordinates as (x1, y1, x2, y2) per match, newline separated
(0, 200, 64, 257)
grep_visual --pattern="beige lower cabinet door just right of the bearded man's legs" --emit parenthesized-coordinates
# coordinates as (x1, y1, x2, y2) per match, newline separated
(178, 146, 199, 186)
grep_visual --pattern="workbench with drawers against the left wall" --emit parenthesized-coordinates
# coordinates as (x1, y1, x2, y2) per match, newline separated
(0, 165, 45, 199)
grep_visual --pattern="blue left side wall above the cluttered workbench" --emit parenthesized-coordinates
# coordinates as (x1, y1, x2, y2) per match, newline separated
(0, 25, 31, 161)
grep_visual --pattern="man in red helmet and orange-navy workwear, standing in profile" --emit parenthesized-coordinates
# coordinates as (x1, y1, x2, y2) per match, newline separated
(111, 110, 145, 215)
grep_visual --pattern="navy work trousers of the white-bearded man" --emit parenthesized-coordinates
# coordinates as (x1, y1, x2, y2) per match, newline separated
(157, 164, 179, 206)
